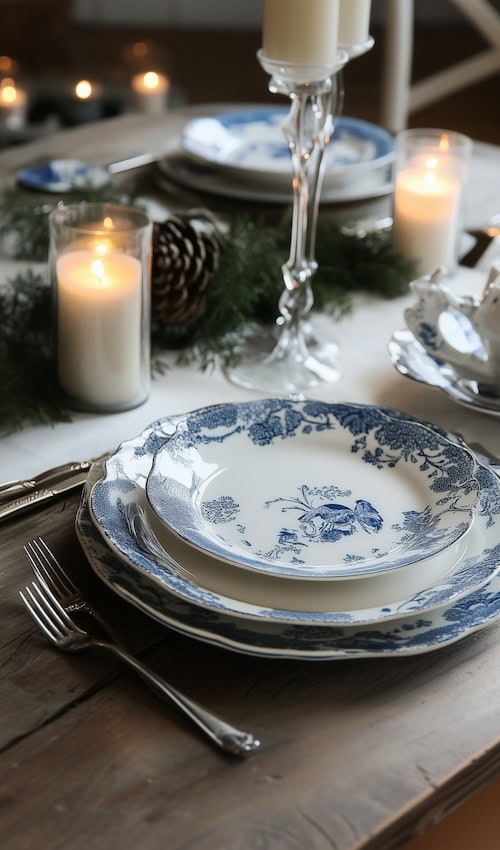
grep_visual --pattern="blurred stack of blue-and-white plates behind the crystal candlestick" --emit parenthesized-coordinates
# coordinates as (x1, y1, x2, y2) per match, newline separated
(158, 106, 394, 203)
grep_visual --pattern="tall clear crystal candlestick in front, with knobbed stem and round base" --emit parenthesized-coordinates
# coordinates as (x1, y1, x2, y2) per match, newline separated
(226, 50, 348, 395)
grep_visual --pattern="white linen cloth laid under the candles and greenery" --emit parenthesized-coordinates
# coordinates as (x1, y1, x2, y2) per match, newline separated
(0, 109, 500, 481)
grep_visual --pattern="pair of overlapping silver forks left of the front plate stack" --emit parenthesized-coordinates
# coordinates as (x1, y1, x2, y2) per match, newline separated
(20, 538, 260, 756)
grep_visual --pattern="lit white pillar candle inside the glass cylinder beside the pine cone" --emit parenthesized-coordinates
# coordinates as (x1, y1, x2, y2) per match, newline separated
(56, 250, 142, 407)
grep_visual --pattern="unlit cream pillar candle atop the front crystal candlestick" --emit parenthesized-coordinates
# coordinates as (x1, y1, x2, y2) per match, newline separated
(262, 0, 340, 65)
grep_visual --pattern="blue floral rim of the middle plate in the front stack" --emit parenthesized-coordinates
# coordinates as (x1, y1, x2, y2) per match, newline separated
(88, 400, 500, 632)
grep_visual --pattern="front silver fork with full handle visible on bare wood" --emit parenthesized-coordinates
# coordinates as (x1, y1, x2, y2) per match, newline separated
(19, 552, 260, 756)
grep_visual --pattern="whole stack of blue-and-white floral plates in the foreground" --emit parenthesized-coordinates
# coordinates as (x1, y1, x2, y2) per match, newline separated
(77, 399, 500, 660)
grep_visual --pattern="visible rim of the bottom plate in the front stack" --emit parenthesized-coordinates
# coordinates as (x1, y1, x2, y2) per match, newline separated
(76, 448, 500, 661)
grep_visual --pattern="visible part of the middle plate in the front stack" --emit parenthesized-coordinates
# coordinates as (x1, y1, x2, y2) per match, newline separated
(85, 408, 500, 627)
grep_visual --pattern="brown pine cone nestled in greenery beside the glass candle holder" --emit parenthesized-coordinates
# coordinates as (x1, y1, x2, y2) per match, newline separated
(152, 216, 219, 325)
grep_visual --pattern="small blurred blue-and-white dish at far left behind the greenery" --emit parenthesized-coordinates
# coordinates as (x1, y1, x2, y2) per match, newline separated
(16, 159, 111, 193)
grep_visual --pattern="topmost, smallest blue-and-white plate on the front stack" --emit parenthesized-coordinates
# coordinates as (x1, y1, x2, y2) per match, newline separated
(146, 399, 478, 580)
